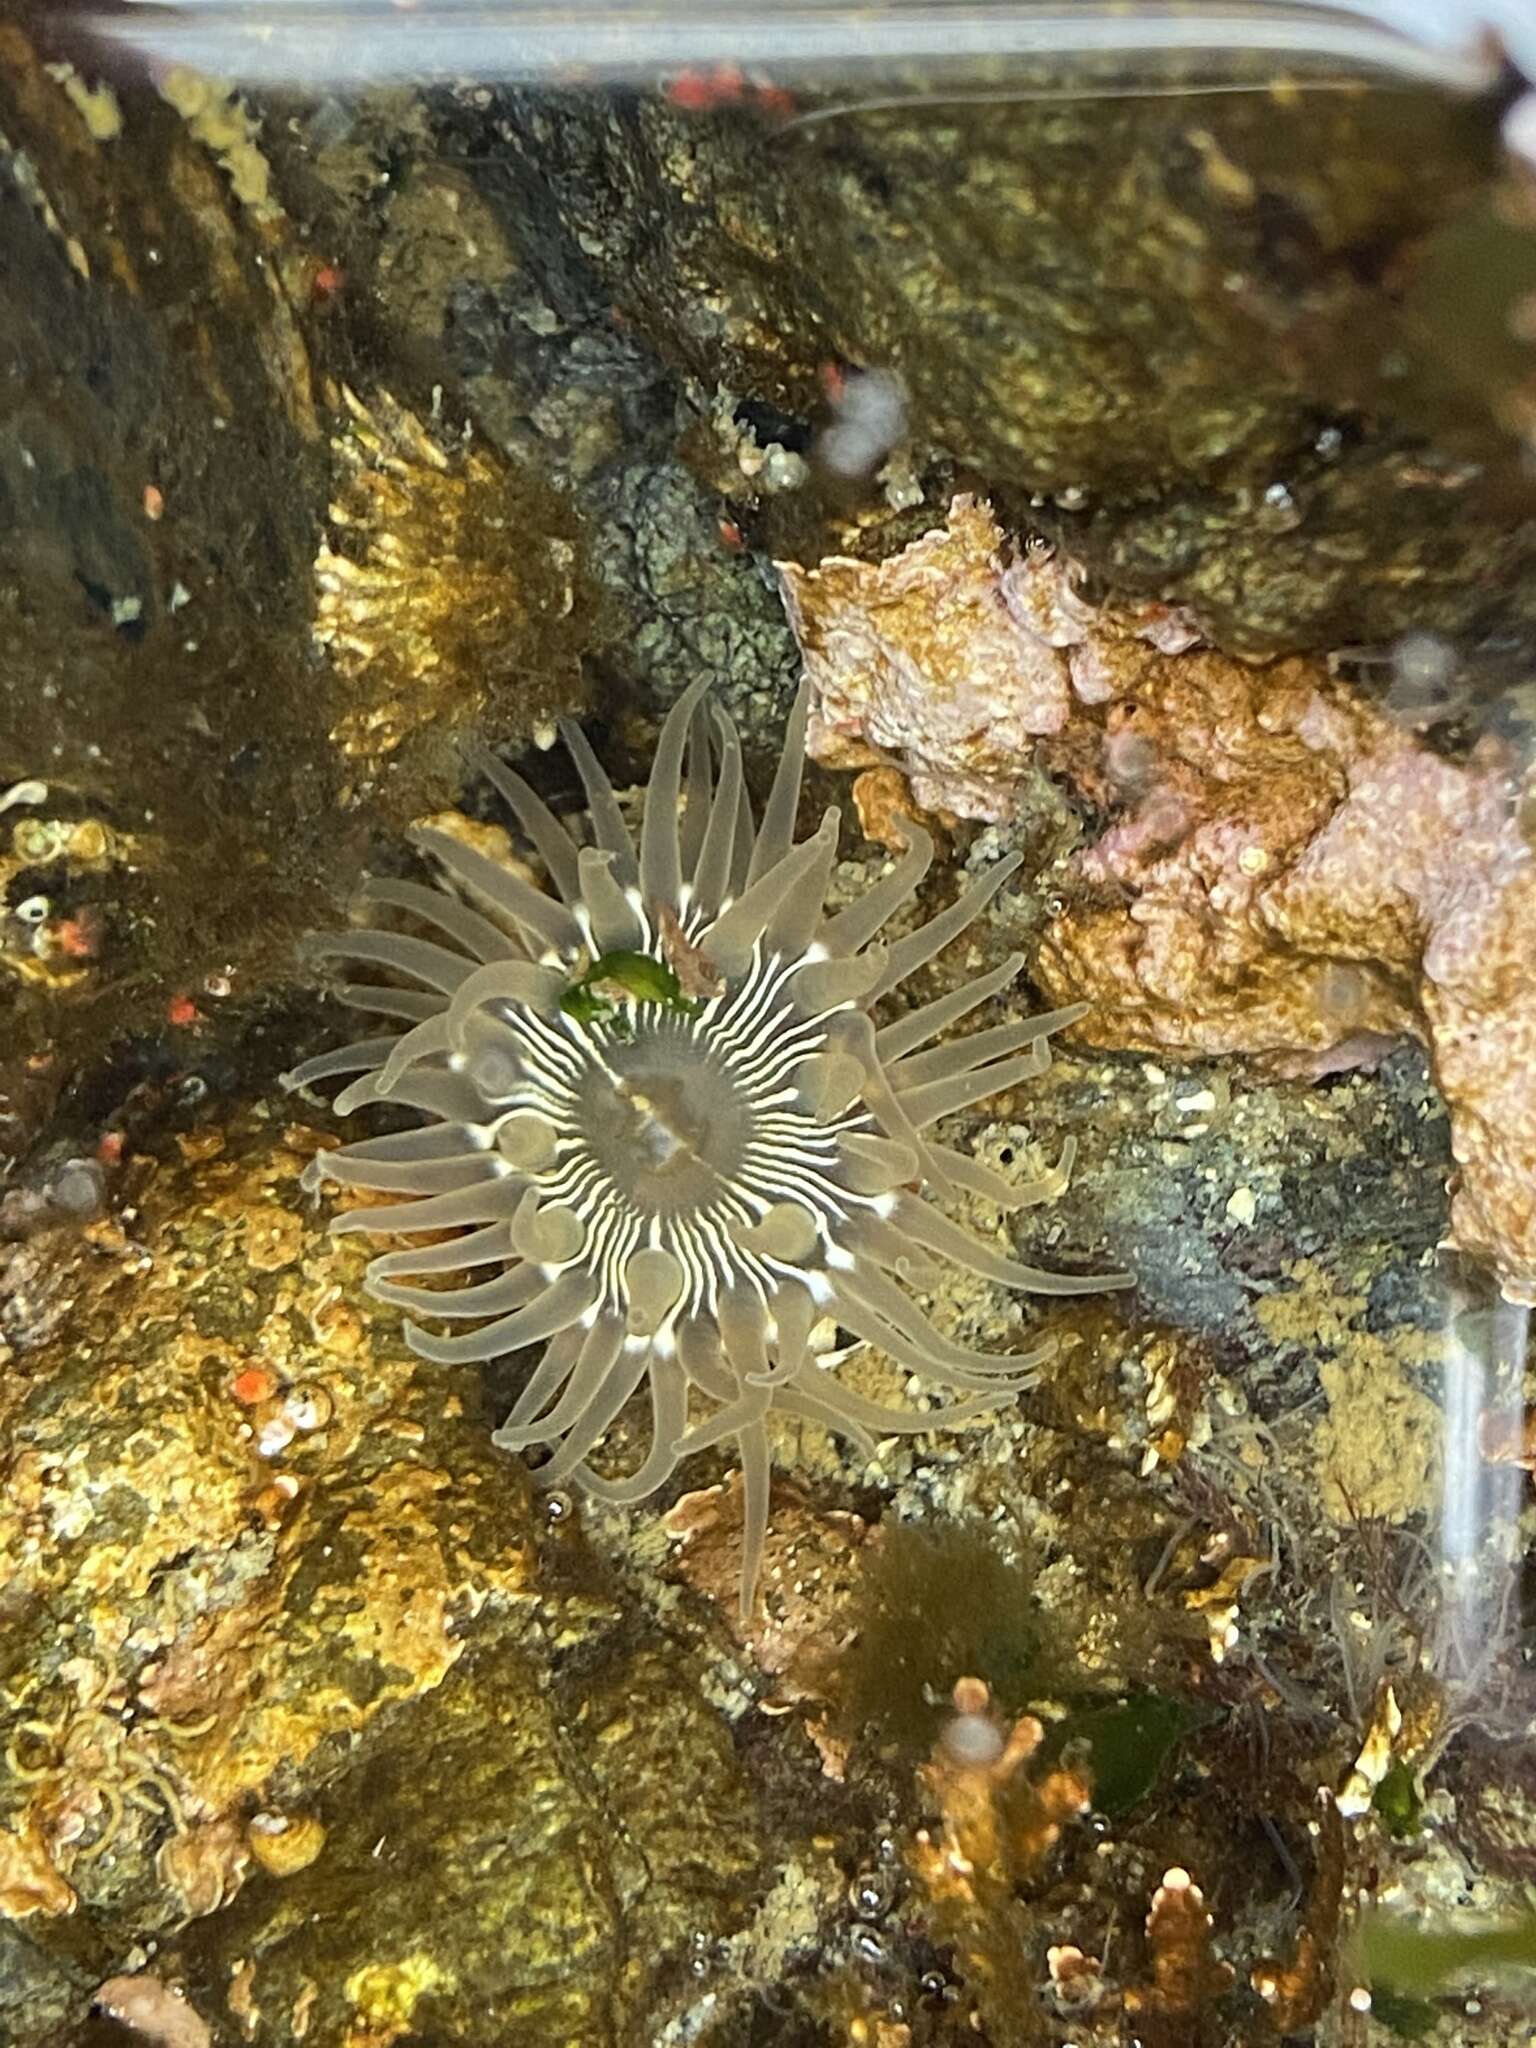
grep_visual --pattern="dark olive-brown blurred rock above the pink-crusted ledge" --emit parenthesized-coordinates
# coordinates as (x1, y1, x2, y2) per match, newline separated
(493, 72, 1536, 651)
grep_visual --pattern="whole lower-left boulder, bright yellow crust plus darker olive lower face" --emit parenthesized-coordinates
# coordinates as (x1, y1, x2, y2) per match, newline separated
(0, 1120, 762, 2048)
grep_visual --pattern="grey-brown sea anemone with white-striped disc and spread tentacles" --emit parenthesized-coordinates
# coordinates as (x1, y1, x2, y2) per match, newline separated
(291, 686, 1122, 1612)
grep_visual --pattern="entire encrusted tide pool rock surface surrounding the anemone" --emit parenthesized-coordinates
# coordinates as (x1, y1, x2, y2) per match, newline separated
(0, 19, 1536, 2048)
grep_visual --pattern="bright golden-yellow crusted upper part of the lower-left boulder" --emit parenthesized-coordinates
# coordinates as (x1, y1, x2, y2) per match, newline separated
(0, 1114, 530, 1892)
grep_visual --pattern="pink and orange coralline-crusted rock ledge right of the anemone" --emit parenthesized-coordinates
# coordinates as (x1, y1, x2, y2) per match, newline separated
(786, 500, 1536, 1303)
